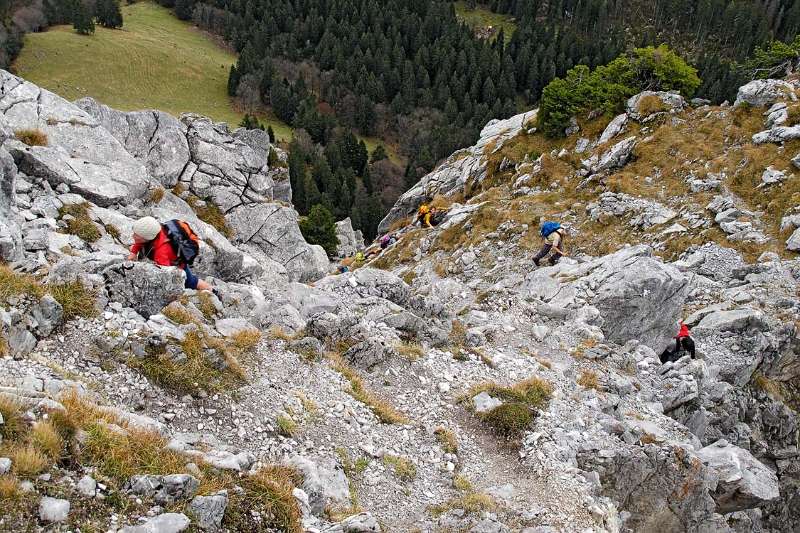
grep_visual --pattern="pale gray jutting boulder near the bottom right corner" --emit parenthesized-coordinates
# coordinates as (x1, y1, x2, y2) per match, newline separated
(697, 440, 780, 513)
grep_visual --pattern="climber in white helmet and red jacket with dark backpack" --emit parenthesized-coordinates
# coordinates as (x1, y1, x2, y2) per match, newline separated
(128, 217, 219, 297)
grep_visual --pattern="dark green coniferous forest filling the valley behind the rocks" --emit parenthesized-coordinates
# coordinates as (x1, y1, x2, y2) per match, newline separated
(0, 0, 800, 236)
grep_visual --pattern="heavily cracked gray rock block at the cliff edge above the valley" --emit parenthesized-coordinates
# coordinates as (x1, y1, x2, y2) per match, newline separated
(181, 115, 274, 210)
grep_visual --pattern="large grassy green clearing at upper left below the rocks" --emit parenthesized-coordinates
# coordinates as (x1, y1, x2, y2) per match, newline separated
(14, 2, 291, 139)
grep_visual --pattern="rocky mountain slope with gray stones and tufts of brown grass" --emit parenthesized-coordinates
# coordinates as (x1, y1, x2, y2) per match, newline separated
(0, 73, 800, 533)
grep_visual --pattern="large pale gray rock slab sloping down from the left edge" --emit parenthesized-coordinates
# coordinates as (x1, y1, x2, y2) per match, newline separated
(0, 71, 149, 206)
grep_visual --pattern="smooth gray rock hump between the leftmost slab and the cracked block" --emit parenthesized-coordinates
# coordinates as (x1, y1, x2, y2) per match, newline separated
(75, 98, 189, 188)
